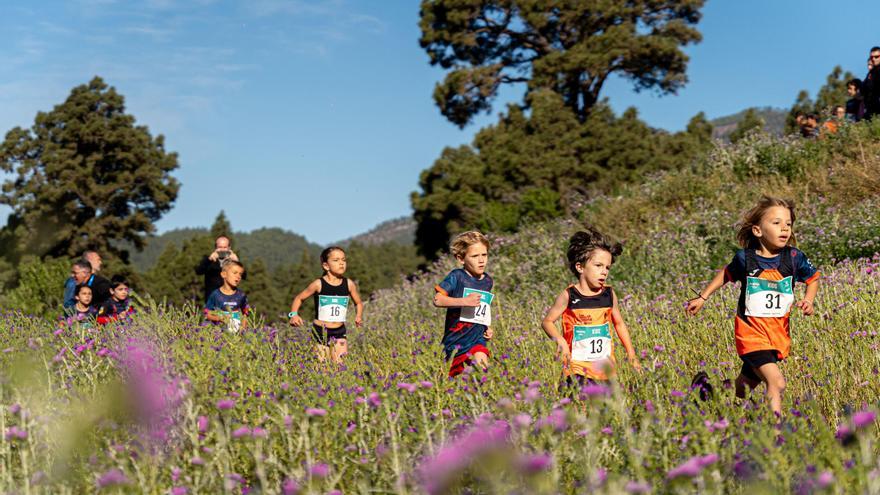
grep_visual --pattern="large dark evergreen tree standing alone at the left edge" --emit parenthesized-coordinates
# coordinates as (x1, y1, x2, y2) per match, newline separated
(0, 77, 178, 259)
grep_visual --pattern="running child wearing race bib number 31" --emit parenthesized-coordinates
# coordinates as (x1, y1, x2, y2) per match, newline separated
(687, 196, 820, 415)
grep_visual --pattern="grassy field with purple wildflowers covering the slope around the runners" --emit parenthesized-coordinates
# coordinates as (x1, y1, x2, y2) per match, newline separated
(0, 127, 880, 494)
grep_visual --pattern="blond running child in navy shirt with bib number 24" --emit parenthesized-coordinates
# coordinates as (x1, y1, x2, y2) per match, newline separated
(434, 231, 495, 377)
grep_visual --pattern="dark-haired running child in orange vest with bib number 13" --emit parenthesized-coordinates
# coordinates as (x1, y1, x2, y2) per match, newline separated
(541, 227, 641, 386)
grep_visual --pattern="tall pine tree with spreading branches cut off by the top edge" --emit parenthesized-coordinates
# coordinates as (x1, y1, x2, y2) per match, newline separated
(419, 0, 704, 127)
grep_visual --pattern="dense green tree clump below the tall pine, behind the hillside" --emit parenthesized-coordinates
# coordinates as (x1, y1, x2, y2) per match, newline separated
(412, 91, 712, 257)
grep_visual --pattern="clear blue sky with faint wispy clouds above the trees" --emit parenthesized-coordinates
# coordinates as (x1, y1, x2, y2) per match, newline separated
(0, 0, 880, 243)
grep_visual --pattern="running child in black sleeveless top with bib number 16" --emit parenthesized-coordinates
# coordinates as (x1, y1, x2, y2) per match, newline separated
(287, 246, 364, 363)
